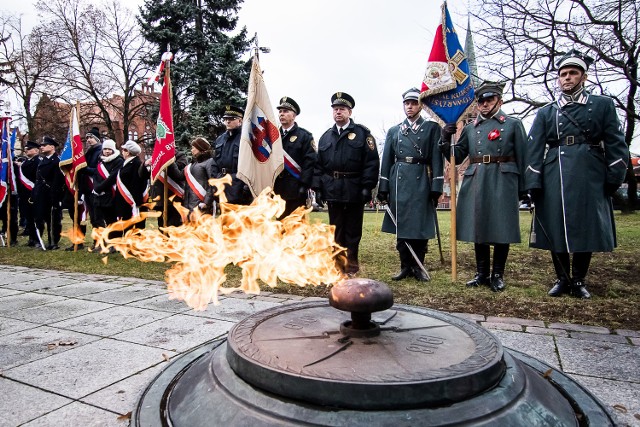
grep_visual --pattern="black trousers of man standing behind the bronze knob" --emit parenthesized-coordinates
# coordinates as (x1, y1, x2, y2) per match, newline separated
(328, 202, 364, 273)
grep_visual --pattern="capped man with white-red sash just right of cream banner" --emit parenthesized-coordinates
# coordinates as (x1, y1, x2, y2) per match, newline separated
(273, 96, 317, 218)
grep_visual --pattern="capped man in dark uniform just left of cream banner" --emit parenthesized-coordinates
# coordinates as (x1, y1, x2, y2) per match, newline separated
(214, 105, 253, 205)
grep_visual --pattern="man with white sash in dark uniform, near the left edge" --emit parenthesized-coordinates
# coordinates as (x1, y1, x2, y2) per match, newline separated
(16, 141, 40, 247)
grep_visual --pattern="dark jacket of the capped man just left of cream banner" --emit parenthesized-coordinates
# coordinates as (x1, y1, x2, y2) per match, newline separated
(214, 128, 253, 205)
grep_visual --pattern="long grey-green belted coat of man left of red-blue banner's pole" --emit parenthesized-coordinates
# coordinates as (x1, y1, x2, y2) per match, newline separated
(378, 117, 444, 240)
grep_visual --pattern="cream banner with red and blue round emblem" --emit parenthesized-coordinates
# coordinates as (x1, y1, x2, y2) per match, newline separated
(237, 56, 284, 197)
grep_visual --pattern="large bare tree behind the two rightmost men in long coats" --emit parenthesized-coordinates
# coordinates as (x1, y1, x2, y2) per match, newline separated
(471, 0, 640, 211)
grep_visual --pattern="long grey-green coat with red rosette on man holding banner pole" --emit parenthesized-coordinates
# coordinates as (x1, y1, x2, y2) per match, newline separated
(445, 110, 527, 243)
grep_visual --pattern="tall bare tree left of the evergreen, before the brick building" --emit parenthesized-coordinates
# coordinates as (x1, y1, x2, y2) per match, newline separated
(36, 0, 157, 140)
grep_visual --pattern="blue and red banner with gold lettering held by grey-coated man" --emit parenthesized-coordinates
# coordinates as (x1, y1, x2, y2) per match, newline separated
(420, 2, 474, 125)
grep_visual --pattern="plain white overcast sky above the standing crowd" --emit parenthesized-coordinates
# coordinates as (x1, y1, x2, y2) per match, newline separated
(0, 0, 476, 139)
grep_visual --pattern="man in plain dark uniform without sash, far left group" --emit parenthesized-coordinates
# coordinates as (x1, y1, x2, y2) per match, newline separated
(33, 136, 64, 250)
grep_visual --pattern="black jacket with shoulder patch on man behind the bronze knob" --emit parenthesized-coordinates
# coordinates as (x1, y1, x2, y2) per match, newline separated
(313, 120, 380, 203)
